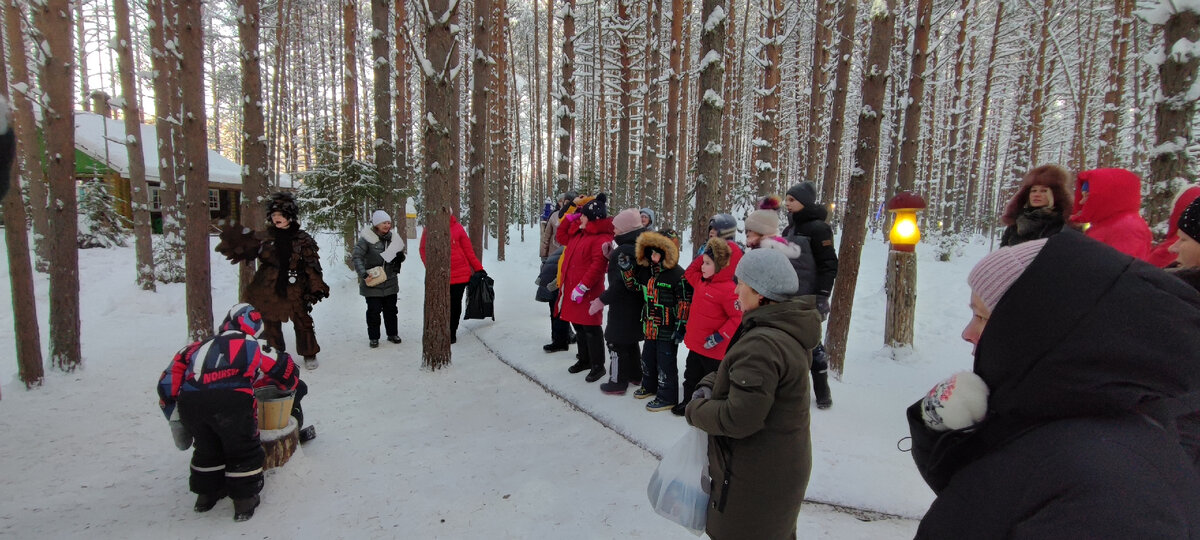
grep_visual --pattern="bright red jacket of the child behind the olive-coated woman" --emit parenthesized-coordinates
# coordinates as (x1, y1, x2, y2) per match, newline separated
(683, 242, 742, 360)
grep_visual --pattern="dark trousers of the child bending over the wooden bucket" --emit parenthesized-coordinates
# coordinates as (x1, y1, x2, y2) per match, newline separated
(178, 390, 265, 499)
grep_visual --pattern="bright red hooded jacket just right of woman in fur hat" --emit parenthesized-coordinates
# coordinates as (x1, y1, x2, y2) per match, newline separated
(1070, 169, 1151, 260)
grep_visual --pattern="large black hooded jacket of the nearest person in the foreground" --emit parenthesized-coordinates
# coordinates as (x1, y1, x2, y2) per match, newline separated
(910, 230, 1200, 539)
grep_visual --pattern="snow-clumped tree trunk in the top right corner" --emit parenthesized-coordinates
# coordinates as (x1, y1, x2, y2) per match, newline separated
(1146, 2, 1200, 229)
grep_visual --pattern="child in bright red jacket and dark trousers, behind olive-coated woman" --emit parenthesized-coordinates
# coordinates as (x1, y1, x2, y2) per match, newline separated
(671, 238, 742, 416)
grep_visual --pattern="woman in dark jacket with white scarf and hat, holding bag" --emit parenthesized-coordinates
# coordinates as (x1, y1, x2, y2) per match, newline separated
(354, 210, 407, 349)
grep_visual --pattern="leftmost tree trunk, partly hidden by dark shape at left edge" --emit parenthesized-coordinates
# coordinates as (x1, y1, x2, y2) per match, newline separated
(0, 28, 46, 389)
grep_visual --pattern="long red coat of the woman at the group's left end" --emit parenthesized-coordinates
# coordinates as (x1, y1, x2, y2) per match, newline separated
(554, 217, 613, 326)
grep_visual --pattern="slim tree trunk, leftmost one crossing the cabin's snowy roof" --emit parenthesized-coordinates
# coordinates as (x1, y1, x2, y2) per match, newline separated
(113, 0, 156, 290)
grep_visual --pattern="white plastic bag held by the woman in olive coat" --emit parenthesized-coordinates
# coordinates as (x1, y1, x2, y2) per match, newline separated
(646, 427, 710, 536)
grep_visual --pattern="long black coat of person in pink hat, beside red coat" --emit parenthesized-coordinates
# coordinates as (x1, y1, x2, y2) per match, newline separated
(600, 228, 646, 344)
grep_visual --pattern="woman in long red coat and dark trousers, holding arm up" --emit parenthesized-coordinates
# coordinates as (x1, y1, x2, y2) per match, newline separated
(554, 193, 613, 383)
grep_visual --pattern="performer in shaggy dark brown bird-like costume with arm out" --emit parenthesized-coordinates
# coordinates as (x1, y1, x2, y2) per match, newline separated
(216, 192, 329, 370)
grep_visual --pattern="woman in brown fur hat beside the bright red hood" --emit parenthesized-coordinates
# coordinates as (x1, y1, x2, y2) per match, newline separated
(1000, 164, 1070, 247)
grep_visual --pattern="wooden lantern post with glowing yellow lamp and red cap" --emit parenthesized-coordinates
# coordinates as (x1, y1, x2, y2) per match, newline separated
(883, 192, 926, 347)
